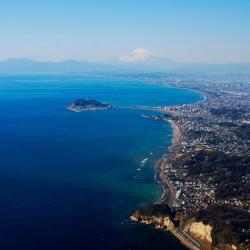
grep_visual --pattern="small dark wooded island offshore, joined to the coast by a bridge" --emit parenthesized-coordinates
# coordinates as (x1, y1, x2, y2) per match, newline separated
(66, 98, 112, 112)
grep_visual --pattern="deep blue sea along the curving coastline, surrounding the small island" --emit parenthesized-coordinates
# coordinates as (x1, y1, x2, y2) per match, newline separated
(0, 76, 202, 250)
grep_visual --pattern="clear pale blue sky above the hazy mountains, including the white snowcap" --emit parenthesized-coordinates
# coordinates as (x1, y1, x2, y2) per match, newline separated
(0, 0, 250, 63)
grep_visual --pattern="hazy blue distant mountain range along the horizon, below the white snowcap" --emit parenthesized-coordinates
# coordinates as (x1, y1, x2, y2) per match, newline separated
(0, 57, 250, 75)
